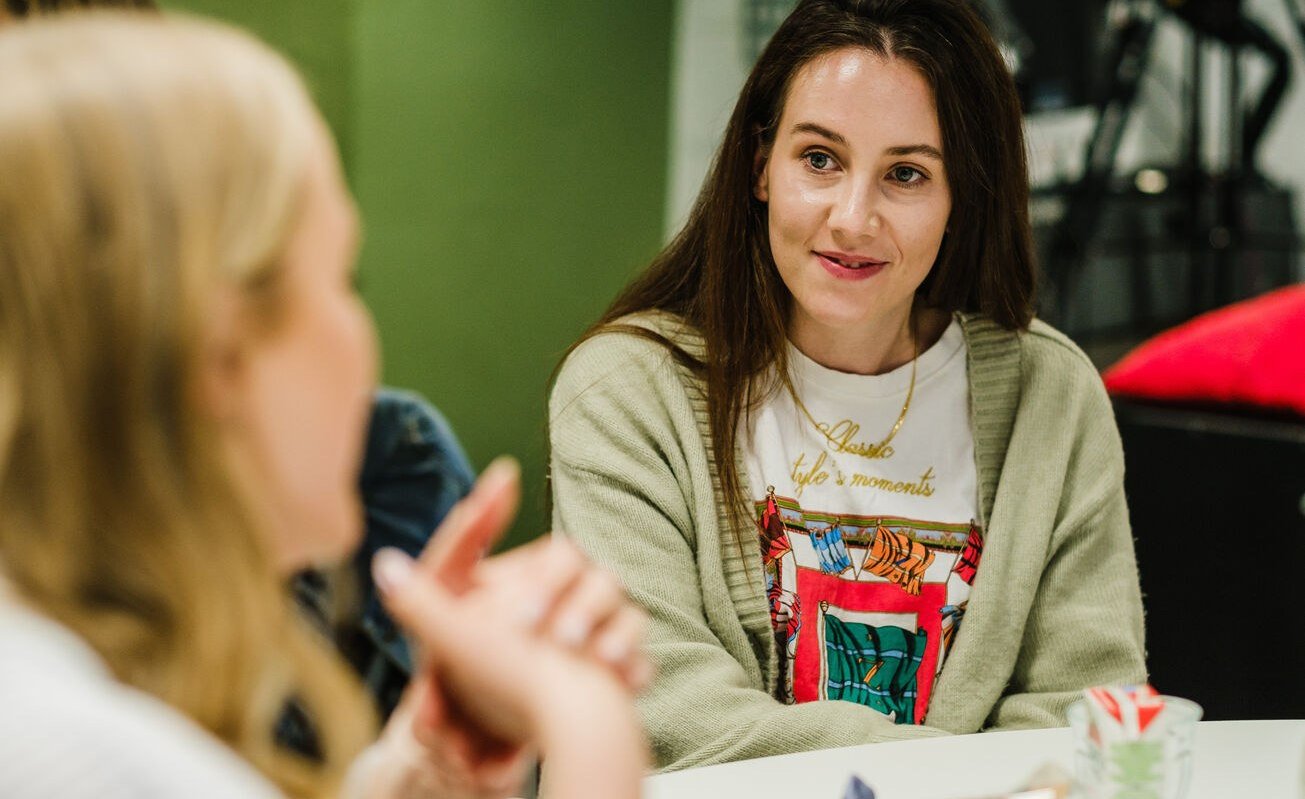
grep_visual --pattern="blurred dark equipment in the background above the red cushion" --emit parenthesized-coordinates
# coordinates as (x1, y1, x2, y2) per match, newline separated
(1021, 0, 1302, 345)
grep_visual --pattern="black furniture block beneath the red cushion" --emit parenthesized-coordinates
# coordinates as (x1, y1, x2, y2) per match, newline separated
(1116, 401, 1305, 719)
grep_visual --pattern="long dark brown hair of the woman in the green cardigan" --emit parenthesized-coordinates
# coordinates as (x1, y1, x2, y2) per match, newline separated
(561, 0, 1035, 548)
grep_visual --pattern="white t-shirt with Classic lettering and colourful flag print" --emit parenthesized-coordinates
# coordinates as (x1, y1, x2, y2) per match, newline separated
(743, 321, 983, 723)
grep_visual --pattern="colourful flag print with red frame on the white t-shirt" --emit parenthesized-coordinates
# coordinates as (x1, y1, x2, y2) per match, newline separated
(757, 492, 983, 723)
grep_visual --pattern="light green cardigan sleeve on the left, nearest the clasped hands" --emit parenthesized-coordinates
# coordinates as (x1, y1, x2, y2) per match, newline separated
(549, 330, 941, 770)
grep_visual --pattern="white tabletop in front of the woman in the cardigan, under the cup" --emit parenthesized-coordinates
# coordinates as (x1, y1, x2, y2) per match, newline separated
(643, 721, 1305, 799)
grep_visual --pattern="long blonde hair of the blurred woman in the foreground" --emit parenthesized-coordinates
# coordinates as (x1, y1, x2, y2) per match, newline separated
(0, 12, 375, 796)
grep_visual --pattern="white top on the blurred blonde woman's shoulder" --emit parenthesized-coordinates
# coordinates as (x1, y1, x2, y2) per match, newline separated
(0, 600, 282, 799)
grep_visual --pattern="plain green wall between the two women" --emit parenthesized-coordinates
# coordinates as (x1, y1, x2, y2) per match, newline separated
(167, 0, 673, 542)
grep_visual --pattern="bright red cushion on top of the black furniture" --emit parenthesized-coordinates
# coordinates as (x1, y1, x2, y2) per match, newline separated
(1105, 286, 1305, 416)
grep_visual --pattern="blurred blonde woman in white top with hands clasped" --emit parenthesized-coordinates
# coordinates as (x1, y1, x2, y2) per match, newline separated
(0, 14, 646, 799)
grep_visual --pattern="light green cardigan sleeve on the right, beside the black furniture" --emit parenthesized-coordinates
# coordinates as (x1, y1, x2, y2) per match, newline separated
(988, 352, 1146, 729)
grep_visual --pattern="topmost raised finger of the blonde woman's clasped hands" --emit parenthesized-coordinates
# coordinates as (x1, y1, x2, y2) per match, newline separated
(419, 457, 521, 594)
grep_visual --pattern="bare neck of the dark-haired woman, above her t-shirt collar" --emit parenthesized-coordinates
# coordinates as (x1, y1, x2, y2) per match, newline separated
(788, 308, 951, 375)
